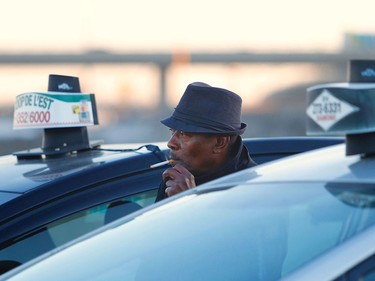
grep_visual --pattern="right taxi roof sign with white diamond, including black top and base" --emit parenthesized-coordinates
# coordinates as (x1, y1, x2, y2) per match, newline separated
(306, 60, 375, 155)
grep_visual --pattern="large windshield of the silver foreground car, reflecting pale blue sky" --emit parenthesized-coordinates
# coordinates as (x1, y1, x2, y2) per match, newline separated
(4, 180, 375, 281)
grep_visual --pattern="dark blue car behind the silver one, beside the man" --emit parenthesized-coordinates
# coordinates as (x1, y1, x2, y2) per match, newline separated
(0, 132, 344, 272)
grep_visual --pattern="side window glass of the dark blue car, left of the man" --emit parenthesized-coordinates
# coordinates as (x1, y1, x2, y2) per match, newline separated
(0, 189, 157, 272)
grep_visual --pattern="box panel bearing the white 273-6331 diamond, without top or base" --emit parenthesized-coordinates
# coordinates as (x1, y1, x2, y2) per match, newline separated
(306, 83, 375, 135)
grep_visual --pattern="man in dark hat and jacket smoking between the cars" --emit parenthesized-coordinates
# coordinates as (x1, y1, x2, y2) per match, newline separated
(156, 82, 256, 201)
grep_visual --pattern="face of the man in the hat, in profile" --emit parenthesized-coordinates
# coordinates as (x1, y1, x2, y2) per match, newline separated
(168, 130, 216, 176)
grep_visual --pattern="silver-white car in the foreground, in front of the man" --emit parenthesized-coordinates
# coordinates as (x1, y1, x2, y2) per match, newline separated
(0, 139, 375, 281)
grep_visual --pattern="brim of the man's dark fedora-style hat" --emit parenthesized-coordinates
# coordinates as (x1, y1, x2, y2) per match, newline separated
(160, 116, 247, 135)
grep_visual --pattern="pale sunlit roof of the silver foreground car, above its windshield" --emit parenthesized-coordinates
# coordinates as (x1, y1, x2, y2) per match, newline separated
(199, 144, 375, 189)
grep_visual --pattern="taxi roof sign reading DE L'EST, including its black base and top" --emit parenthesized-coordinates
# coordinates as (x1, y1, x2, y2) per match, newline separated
(13, 74, 100, 158)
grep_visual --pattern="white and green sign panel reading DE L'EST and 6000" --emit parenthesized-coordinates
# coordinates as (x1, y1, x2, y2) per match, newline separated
(13, 92, 97, 129)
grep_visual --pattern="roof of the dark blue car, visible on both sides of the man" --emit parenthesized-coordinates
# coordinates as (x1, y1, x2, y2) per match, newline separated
(0, 137, 343, 195)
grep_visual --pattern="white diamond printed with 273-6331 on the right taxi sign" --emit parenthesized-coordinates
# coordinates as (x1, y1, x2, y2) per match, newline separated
(306, 89, 359, 131)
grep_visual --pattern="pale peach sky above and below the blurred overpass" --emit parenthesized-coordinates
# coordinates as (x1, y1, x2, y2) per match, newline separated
(0, 0, 375, 111)
